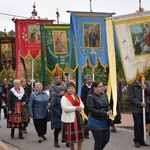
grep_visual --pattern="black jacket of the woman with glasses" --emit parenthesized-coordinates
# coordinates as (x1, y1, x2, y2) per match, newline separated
(87, 93, 110, 120)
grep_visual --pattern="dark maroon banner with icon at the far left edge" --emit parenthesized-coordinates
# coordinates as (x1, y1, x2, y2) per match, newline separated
(0, 37, 15, 71)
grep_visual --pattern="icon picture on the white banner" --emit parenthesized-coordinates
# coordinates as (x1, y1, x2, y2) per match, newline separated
(130, 23, 150, 55)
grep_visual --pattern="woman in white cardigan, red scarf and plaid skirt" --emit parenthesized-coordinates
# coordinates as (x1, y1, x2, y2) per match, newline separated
(61, 81, 84, 150)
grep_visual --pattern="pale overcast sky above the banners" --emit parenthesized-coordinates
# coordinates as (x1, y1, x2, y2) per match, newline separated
(0, 0, 150, 31)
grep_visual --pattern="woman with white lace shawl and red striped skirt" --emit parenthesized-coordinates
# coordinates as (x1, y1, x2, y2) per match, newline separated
(7, 79, 28, 139)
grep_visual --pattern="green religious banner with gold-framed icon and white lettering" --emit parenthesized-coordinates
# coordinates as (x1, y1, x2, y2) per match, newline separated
(44, 24, 73, 72)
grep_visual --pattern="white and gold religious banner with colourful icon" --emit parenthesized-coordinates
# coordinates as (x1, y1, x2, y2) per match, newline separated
(114, 11, 150, 83)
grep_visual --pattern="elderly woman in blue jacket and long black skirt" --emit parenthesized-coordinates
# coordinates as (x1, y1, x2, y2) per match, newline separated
(28, 83, 48, 143)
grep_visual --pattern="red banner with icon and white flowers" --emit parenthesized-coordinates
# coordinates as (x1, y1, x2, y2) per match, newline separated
(14, 19, 54, 78)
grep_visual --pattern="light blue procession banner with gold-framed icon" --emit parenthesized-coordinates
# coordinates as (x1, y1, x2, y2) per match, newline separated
(69, 12, 112, 95)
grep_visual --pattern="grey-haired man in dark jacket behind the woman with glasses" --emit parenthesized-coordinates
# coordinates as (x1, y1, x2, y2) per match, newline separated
(81, 74, 92, 139)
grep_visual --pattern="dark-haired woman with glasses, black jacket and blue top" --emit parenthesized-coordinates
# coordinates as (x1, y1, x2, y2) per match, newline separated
(87, 81, 112, 150)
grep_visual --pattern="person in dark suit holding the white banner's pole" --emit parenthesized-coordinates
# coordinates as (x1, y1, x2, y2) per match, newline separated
(128, 74, 150, 148)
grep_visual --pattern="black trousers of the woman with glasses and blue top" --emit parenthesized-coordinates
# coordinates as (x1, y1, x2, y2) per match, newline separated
(91, 129, 110, 150)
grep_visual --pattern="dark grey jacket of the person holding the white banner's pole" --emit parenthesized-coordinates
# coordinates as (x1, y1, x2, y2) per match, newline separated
(128, 81, 150, 113)
